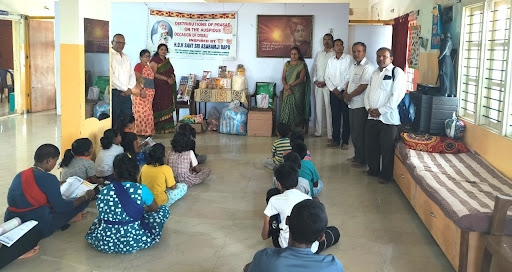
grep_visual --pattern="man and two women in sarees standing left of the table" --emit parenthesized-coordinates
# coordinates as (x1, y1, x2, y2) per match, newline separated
(110, 34, 177, 136)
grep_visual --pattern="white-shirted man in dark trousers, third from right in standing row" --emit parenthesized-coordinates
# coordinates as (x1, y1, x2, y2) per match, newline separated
(325, 39, 352, 150)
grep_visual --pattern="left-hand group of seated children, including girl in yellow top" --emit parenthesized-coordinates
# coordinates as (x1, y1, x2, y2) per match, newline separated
(4, 124, 211, 264)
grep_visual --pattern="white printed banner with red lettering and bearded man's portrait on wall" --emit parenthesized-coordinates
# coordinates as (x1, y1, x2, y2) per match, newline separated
(147, 10, 237, 60)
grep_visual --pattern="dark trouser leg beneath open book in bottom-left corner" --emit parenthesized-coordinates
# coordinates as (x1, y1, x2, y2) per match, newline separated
(0, 227, 42, 269)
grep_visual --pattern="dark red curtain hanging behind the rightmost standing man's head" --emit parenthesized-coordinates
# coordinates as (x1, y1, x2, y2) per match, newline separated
(391, 14, 409, 71)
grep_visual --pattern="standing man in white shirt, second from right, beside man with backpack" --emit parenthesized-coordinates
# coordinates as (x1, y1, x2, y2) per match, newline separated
(343, 42, 375, 167)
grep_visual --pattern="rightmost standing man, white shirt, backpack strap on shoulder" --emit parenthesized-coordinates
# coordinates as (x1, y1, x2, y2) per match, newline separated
(364, 47, 406, 183)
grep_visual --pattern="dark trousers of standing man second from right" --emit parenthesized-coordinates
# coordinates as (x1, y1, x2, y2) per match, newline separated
(348, 107, 368, 165)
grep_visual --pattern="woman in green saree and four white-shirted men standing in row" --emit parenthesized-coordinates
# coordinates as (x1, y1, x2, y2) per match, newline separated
(280, 33, 406, 183)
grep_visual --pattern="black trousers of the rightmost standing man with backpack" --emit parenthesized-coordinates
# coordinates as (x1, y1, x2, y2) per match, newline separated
(366, 119, 398, 181)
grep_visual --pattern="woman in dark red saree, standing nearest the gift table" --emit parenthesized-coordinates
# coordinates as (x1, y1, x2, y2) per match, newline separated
(149, 44, 176, 133)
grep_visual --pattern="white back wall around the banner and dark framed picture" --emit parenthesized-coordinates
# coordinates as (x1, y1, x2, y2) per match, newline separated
(110, 3, 349, 119)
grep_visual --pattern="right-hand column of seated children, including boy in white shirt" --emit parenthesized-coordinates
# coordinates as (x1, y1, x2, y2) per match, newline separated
(251, 123, 343, 271)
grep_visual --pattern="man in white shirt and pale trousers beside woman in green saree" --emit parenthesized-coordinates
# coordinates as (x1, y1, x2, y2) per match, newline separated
(313, 33, 334, 139)
